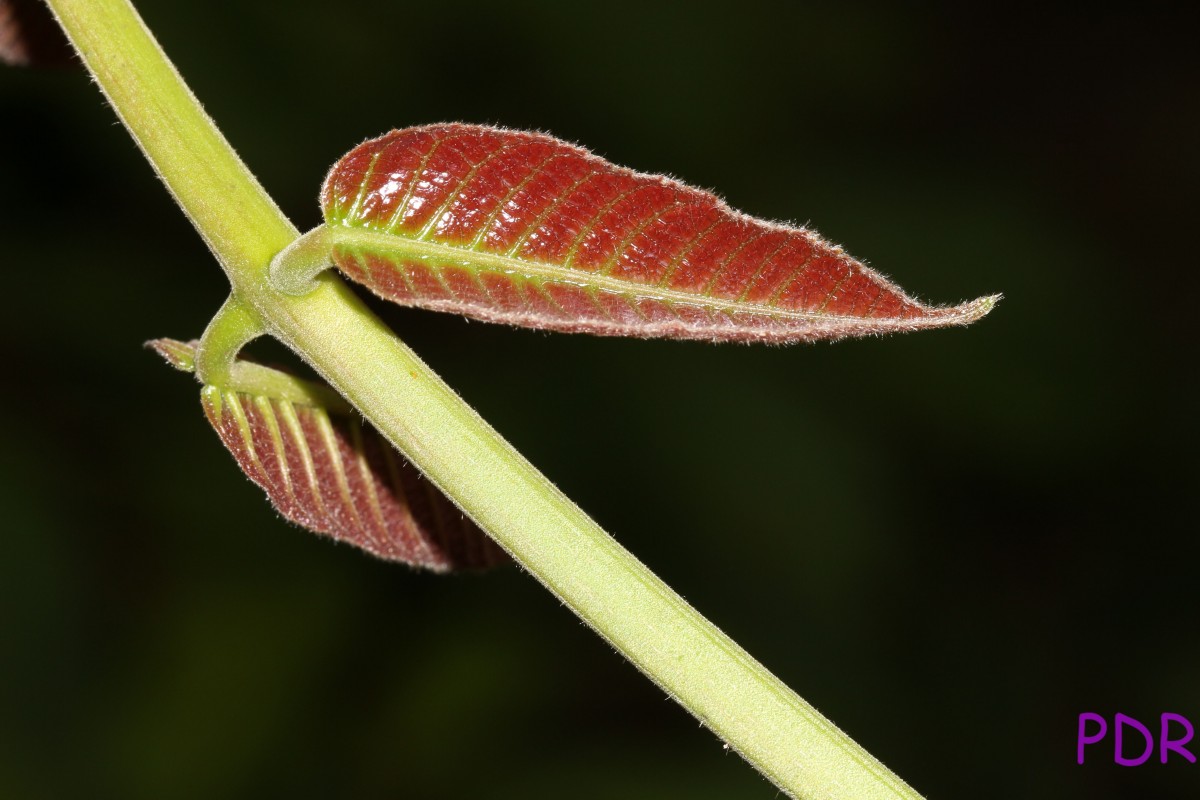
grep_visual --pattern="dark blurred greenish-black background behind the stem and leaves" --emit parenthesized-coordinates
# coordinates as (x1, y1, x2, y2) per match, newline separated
(0, 0, 1200, 800)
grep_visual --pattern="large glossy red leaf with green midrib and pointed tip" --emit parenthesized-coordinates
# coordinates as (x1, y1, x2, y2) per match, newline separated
(320, 124, 998, 343)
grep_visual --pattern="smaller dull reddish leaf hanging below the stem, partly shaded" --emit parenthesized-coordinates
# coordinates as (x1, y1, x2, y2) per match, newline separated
(148, 339, 508, 572)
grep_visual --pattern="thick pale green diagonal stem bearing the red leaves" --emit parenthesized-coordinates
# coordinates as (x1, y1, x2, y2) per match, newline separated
(48, 0, 919, 800)
